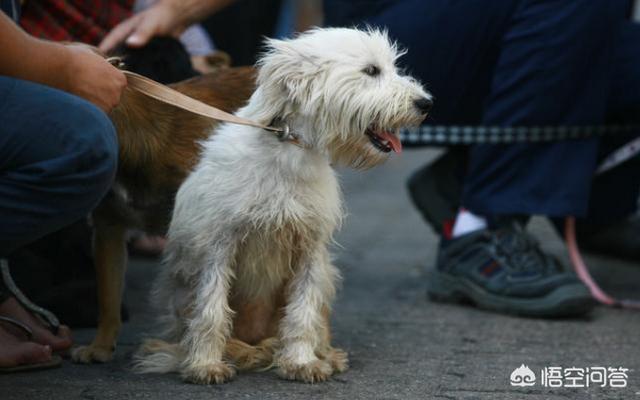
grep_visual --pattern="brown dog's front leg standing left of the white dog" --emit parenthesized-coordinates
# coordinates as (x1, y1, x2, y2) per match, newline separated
(72, 218, 127, 363)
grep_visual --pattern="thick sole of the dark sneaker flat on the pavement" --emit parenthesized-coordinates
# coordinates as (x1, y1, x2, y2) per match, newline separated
(427, 271, 595, 318)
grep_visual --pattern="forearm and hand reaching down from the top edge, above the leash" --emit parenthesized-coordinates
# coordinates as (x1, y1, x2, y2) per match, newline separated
(100, 0, 236, 52)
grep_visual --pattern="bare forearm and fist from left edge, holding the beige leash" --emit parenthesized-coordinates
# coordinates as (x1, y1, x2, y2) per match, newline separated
(0, 12, 127, 111)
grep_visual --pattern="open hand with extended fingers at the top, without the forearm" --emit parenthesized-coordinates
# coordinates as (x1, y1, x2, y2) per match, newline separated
(99, 1, 191, 53)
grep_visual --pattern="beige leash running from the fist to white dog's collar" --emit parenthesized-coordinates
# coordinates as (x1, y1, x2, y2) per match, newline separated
(107, 57, 306, 147)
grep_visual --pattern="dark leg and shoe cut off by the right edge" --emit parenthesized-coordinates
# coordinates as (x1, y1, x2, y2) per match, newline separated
(568, 21, 640, 261)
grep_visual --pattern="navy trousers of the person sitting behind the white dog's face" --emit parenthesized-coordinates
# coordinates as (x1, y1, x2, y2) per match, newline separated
(325, 0, 640, 220)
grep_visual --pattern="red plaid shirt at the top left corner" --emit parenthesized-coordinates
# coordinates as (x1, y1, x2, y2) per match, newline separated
(20, 0, 134, 45)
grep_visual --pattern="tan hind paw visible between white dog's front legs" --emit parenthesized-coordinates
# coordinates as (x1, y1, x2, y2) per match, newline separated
(225, 337, 279, 371)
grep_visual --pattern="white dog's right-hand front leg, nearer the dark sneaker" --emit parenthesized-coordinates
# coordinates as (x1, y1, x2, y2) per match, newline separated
(276, 248, 338, 383)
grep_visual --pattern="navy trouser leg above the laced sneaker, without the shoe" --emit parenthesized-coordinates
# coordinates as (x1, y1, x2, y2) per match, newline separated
(462, 0, 627, 216)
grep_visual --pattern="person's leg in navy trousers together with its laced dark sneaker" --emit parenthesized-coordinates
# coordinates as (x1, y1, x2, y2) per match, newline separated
(430, 0, 627, 316)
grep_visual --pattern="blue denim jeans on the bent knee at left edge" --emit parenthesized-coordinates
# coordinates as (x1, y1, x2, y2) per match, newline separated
(0, 76, 118, 256)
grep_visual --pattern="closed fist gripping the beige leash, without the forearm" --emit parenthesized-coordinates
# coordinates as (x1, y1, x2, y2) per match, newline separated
(62, 44, 127, 112)
